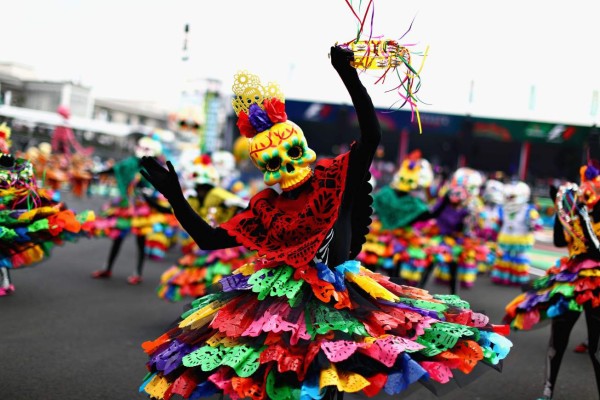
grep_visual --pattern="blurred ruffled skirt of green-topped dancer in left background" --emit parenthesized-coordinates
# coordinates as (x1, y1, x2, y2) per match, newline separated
(94, 197, 179, 260)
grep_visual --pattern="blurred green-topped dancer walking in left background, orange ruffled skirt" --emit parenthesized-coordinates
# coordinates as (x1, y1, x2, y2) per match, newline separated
(92, 137, 177, 285)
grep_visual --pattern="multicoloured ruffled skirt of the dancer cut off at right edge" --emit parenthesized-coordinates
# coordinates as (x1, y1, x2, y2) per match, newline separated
(504, 257, 600, 329)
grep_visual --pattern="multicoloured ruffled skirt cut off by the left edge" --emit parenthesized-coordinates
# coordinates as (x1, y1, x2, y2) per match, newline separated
(0, 204, 95, 269)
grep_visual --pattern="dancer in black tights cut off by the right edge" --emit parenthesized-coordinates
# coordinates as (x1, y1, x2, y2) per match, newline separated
(504, 173, 600, 400)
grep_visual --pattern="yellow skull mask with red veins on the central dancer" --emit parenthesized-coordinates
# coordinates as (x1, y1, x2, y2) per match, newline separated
(249, 121, 317, 190)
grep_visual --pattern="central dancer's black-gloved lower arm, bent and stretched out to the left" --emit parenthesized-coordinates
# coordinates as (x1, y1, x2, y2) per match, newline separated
(140, 157, 239, 250)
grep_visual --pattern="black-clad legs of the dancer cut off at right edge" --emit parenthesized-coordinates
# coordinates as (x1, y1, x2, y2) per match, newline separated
(544, 302, 600, 397)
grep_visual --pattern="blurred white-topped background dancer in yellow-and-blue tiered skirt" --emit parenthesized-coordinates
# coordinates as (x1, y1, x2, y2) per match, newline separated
(490, 182, 540, 286)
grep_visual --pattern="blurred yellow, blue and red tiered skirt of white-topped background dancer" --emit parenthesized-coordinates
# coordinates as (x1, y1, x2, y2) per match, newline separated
(490, 233, 535, 286)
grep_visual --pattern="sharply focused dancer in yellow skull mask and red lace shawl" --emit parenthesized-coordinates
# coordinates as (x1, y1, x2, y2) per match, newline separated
(141, 47, 511, 399)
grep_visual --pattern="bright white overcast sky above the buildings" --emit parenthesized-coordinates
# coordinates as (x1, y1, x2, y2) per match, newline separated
(0, 0, 600, 125)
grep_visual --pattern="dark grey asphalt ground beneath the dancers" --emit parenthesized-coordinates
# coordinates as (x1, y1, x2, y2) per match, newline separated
(0, 194, 598, 400)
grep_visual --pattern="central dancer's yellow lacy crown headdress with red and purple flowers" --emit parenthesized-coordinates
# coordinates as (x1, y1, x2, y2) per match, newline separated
(231, 71, 287, 139)
